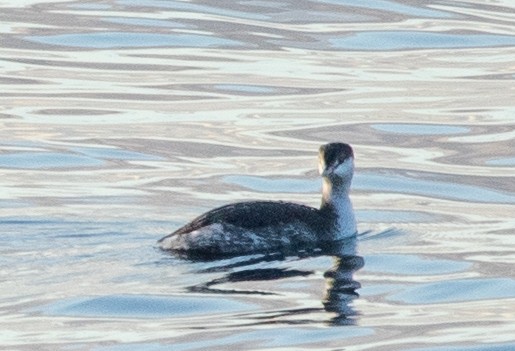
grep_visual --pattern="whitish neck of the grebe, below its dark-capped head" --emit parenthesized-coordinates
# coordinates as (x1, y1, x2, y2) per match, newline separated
(320, 177, 357, 239)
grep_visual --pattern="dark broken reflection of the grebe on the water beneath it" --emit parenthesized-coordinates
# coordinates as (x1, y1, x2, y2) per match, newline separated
(189, 238, 364, 325)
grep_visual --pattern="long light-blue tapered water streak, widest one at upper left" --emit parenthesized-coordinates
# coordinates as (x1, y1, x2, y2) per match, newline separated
(26, 32, 245, 49)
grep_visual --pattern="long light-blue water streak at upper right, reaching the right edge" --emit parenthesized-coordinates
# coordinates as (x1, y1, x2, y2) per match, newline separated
(329, 31, 515, 51)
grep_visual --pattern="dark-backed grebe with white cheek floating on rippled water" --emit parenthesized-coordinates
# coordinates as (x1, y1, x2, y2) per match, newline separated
(158, 143, 357, 257)
